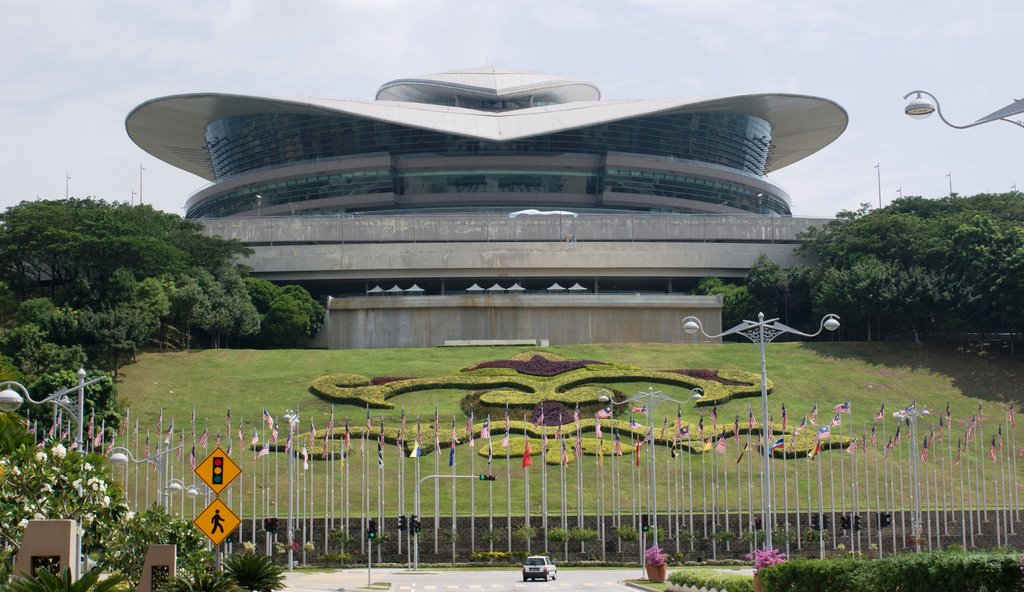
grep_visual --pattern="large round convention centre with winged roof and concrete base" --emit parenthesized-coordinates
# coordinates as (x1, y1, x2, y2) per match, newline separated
(126, 67, 848, 347)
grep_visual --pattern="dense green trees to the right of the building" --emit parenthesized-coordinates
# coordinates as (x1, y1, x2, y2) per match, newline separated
(696, 192, 1024, 344)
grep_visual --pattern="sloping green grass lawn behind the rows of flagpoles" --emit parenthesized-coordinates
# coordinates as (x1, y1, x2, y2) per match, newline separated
(119, 341, 1024, 518)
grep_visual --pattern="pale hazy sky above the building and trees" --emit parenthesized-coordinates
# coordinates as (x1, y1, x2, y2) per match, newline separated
(0, 0, 1024, 217)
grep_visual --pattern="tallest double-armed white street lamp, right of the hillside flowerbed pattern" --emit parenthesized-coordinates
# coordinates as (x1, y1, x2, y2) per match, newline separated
(683, 312, 839, 550)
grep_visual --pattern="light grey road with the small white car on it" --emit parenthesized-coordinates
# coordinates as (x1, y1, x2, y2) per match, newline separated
(285, 567, 642, 592)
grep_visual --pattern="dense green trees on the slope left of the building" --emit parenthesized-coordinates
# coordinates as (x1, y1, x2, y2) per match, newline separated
(0, 199, 324, 425)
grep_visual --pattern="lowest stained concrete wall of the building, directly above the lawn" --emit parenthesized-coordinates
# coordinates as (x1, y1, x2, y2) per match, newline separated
(321, 294, 722, 349)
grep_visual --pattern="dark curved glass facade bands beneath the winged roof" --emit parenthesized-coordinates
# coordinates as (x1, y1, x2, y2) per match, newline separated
(187, 109, 791, 218)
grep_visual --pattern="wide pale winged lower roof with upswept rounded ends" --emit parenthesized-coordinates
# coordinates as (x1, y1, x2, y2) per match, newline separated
(125, 81, 849, 181)
